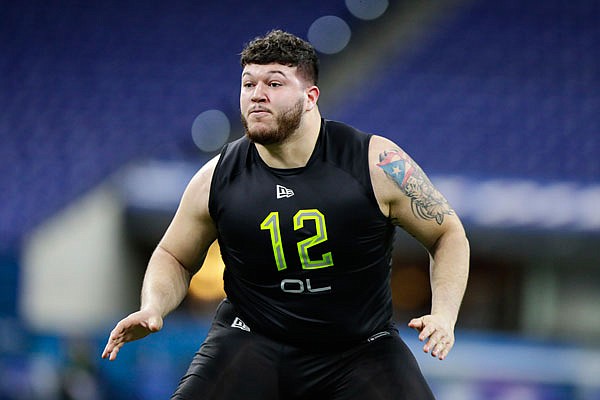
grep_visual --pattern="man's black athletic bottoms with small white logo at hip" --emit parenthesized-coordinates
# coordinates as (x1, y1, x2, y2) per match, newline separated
(171, 300, 434, 400)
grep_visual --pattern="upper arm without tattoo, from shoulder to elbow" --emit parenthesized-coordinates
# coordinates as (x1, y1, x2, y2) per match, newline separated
(159, 156, 217, 274)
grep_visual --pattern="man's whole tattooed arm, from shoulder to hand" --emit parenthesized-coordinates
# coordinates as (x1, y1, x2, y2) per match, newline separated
(369, 136, 469, 360)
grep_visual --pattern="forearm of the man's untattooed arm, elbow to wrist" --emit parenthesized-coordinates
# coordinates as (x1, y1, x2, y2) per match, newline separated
(140, 245, 191, 318)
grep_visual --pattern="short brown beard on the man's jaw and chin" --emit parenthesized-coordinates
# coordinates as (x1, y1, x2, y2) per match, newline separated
(242, 99, 304, 146)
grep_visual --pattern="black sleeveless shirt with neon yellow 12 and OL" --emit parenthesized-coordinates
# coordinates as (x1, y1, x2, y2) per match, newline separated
(209, 120, 394, 346)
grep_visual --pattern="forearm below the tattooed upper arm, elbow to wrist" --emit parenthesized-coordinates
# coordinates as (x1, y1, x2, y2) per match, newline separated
(430, 229, 469, 326)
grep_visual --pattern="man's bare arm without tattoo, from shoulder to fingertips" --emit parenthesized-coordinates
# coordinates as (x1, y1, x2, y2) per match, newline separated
(102, 157, 218, 361)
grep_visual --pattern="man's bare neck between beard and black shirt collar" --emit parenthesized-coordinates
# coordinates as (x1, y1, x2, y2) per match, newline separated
(255, 109, 321, 169)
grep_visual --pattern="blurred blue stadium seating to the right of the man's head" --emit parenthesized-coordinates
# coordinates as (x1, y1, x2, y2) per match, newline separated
(335, 0, 600, 184)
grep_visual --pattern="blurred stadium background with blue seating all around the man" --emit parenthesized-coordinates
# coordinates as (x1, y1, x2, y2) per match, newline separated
(0, 0, 600, 400)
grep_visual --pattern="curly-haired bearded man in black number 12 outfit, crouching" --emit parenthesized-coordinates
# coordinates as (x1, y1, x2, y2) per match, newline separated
(102, 31, 469, 400)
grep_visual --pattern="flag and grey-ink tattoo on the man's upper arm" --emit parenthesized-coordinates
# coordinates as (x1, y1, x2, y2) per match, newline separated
(377, 149, 454, 225)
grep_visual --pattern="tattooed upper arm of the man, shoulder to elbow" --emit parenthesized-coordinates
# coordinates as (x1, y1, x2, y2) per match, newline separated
(370, 137, 457, 247)
